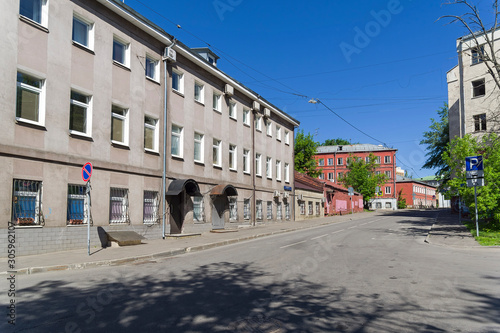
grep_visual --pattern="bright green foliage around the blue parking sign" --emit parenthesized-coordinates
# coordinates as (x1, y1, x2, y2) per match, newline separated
(443, 133, 500, 222)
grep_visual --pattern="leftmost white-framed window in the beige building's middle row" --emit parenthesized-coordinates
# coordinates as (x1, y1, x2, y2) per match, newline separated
(16, 72, 45, 126)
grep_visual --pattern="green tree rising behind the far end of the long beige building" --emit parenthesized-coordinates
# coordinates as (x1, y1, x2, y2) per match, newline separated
(295, 130, 322, 178)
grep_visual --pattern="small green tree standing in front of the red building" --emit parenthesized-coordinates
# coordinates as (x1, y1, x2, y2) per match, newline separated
(340, 154, 387, 207)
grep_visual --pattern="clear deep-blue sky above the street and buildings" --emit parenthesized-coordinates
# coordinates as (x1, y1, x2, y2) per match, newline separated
(125, 0, 491, 177)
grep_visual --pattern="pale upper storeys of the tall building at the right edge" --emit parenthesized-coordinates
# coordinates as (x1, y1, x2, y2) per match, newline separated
(446, 30, 500, 139)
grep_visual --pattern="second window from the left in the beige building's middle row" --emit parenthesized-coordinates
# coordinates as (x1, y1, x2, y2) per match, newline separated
(69, 90, 92, 136)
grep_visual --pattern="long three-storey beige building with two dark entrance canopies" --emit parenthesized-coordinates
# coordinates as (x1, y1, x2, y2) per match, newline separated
(0, 0, 299, 254)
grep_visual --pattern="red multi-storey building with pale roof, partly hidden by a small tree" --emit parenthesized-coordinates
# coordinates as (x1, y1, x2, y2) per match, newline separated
(314, 144, 397, 209)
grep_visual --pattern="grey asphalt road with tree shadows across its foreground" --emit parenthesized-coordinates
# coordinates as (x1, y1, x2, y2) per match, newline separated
(0, 211, 500, 333)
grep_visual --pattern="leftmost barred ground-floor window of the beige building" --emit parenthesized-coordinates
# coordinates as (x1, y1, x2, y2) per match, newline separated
(12, 179, 43, 225)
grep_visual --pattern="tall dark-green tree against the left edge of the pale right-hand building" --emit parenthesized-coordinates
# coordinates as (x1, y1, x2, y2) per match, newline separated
(420, 103, 450, 180)
